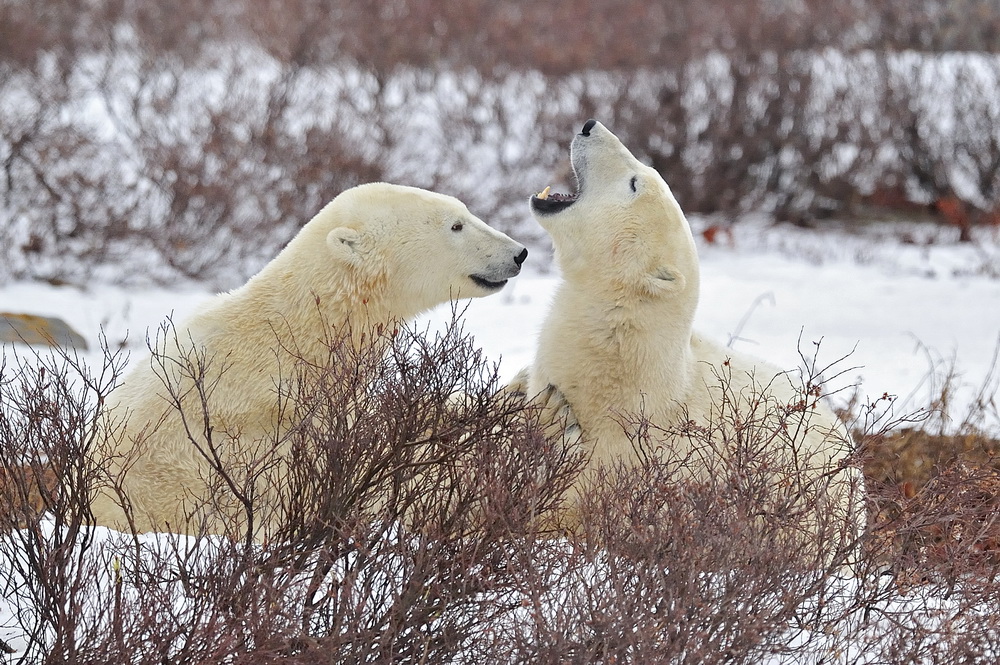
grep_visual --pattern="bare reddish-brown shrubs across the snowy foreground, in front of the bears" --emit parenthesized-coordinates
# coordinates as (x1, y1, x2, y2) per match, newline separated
(0, 325, 1000, 663)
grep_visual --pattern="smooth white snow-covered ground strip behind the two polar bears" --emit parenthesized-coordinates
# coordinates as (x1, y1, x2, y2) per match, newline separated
(0, 220, 1000, 427)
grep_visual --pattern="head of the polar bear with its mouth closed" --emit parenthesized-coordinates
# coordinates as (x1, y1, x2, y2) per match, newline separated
(303, 183, 528, 318)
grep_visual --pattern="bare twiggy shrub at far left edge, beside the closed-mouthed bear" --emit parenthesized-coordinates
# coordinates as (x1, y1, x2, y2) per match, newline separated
(0, 340, 132, 662)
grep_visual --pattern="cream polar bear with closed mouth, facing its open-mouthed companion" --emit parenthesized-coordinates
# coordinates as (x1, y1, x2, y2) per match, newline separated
(92, 183, 528, 531)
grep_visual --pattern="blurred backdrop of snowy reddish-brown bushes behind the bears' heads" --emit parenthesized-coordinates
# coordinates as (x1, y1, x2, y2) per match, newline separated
(0, 0, 1000, 288)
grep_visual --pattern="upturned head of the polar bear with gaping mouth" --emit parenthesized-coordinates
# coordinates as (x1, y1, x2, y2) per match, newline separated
(530, 120, 698, 302)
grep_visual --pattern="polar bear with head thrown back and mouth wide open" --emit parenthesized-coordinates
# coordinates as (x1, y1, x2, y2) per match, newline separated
(528, 120, 859, 536)
